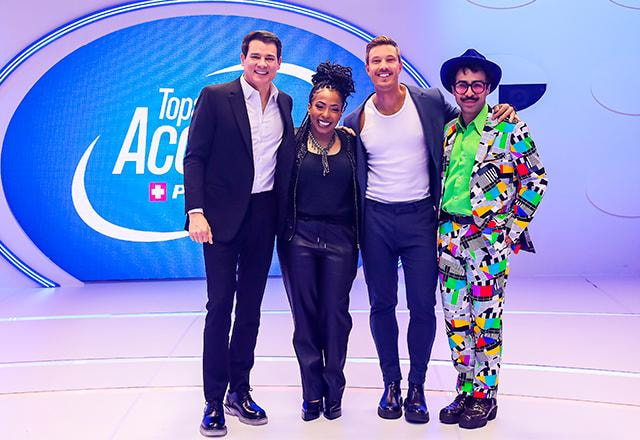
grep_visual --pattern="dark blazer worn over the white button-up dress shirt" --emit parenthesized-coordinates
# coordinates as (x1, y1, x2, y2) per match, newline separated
(184, 78, 295, 242)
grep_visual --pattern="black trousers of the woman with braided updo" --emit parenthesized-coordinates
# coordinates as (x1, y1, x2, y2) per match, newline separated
(278, 219, 358, 402)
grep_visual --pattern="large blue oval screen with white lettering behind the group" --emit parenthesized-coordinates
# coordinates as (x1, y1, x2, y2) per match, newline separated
(1, 16, 371, 281)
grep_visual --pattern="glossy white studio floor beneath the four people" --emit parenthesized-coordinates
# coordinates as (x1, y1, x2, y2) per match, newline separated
(0, 274, 640, 439)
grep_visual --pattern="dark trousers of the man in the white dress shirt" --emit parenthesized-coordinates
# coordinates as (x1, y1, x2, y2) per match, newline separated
(202, 191, 277, 401)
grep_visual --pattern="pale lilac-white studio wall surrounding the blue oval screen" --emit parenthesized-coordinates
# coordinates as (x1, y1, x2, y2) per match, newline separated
(0, 0, 640, 286)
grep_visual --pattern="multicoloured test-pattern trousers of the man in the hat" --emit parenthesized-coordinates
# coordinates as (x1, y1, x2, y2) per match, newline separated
(438, 221, 511, 398)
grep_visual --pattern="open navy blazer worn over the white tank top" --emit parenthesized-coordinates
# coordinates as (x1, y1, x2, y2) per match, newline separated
(345, 86, 459, 229)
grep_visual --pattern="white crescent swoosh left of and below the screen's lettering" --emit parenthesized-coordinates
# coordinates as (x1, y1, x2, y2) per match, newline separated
(71, 136, 189, 243)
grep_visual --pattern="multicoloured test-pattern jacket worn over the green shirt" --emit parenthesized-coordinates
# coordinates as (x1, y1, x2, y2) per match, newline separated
(442, 109, 547, 252)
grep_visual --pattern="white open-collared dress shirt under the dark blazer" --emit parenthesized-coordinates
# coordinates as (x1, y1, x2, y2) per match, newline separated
(240, 75, 284, 194)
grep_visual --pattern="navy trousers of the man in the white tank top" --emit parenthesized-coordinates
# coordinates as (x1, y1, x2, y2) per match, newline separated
(361, 197, 438, 384)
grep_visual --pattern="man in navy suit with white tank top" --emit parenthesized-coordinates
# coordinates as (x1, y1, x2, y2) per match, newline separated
(345, 36, 513, 423)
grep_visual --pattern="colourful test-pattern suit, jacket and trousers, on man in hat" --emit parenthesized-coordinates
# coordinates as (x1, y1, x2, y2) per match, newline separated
(438, 111, 547, 398)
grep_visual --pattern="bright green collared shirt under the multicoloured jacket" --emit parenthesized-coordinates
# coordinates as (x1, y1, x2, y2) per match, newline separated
(442, 105, 489, 215)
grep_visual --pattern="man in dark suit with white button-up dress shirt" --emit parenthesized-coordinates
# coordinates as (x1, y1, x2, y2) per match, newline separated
(184, 31, 294, 436)
